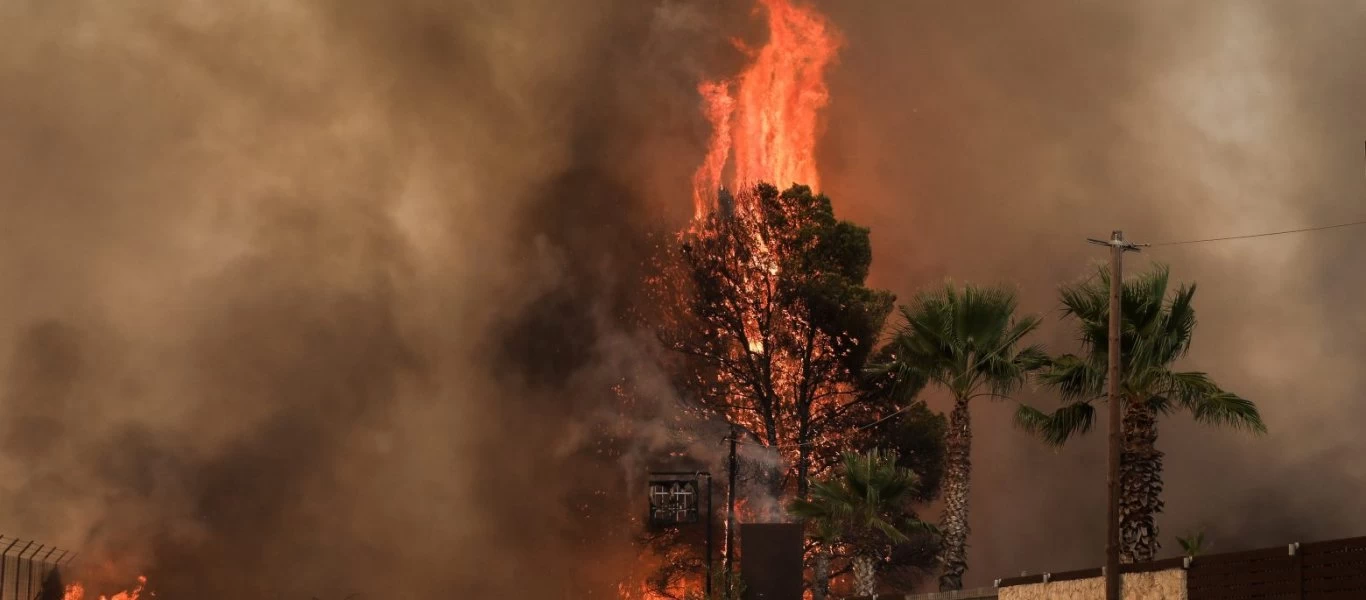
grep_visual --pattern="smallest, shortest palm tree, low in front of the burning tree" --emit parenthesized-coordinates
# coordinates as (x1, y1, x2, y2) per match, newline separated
(788, 448, 928, 600)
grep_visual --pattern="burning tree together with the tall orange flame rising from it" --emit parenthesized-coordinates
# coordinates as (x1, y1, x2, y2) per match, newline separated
(631, 0, 943, 596)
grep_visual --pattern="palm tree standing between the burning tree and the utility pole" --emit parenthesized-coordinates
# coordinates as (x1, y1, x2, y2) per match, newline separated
(872, 286, 1046, 592)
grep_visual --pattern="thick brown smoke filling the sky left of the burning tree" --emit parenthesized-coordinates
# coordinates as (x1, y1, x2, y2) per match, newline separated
(0, 0, 738, 599)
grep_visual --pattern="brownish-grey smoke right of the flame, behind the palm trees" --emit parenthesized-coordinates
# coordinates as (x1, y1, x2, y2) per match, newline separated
(821, 0, 1366, 585)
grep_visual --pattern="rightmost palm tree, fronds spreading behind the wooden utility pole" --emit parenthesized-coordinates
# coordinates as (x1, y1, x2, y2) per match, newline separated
(1016, 265, 1266, 562)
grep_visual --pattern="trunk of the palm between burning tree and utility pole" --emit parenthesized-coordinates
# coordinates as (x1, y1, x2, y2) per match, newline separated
(940, 398, 973, 592)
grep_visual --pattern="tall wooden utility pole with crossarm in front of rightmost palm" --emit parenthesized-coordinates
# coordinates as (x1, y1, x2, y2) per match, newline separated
(1087, 231, 1138, 600)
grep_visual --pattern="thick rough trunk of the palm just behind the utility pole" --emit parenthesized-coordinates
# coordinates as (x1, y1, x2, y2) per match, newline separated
(1120, 402, 1162, 562)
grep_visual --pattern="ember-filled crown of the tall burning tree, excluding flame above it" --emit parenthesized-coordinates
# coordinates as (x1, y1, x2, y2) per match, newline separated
(656, 183, 895, 508)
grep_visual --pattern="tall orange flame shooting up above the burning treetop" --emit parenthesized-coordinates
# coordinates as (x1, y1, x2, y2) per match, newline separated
(693, 0, 839, 217)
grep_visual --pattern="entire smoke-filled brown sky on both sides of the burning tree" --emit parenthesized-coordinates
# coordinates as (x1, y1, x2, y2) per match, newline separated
(0, 0, 1366, 600)
